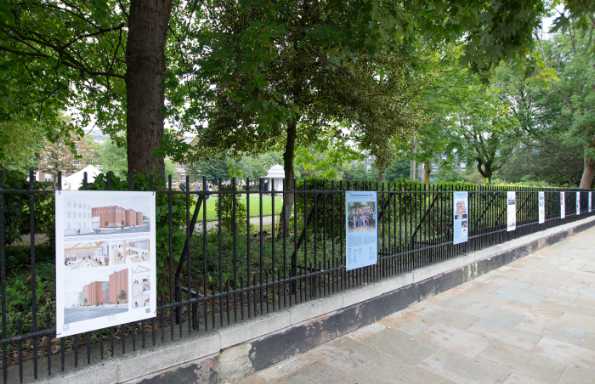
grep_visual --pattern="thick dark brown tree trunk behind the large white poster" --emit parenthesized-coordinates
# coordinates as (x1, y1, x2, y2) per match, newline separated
(126, 0, 172, 182)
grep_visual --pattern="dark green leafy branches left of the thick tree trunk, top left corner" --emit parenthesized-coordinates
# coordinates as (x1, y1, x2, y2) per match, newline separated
(0, 0, 126, 166)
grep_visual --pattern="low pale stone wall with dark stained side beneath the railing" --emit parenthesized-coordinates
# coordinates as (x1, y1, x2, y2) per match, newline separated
(42, 217, 595, 384)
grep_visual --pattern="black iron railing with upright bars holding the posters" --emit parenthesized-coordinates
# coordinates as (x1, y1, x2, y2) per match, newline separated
(0, 173, 595, 383)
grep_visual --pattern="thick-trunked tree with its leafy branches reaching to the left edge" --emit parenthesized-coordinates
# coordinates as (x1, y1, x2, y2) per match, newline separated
(0, 0, 172, 180)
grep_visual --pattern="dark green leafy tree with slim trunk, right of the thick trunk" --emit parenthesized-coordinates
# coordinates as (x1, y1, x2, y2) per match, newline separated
(184, 0, 543, 219)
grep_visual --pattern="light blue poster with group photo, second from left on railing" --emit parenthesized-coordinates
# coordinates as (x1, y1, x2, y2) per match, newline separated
(345, 191, 378, 271)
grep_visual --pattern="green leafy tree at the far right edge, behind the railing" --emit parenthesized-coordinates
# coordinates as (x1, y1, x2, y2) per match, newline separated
(496, 14, 595, 188)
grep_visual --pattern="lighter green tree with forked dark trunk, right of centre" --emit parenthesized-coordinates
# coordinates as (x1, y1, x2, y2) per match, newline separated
(410, 55, 519, 182)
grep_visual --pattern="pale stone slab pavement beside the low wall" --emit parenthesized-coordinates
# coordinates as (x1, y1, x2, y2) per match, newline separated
(242, 228, 595, 384)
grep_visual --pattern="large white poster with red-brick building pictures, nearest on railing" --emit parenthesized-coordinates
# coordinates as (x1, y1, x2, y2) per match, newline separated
(55, 191, 157, 337)
